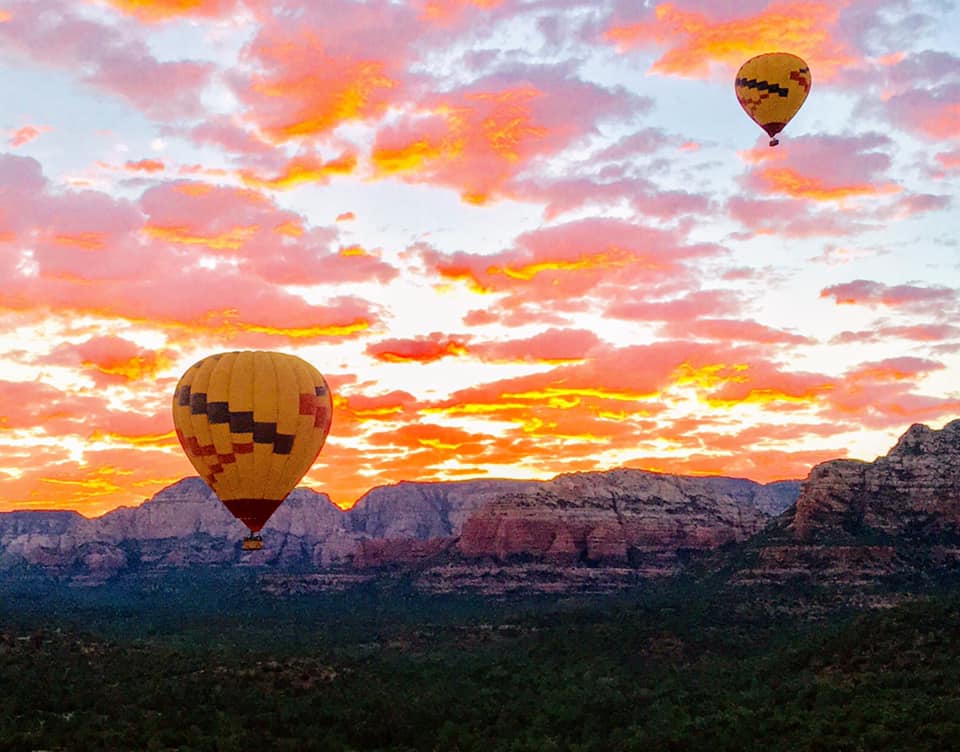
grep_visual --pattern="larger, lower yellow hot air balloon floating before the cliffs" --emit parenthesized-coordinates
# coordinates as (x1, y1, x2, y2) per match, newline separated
(173, 351, 333, 550)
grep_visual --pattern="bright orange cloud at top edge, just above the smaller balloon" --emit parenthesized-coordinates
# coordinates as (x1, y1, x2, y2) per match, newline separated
(606, 1, 857, 80)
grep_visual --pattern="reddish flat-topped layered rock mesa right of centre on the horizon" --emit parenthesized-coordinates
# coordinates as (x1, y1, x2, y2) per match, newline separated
(458, 469, 789, 574)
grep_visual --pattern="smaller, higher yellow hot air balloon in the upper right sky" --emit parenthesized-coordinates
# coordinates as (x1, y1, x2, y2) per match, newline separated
(734, 52, 811, 146)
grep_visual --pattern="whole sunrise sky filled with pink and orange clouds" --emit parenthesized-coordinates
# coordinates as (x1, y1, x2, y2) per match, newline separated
(0, 0, 960, 516)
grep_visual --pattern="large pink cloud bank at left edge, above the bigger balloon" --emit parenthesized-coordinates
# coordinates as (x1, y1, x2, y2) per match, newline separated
(0, 162, 382, 344)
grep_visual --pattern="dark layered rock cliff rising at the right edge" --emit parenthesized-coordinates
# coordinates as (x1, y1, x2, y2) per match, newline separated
(734, 420, 960, 587)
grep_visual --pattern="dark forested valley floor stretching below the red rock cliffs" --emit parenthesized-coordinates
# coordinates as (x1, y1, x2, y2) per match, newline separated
(0, 570, 960, 752)
